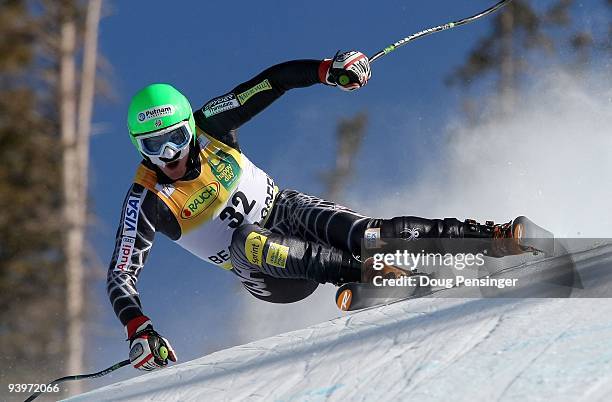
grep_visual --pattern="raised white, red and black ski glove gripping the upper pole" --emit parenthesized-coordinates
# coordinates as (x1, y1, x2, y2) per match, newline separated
(319, 50, 372, 91)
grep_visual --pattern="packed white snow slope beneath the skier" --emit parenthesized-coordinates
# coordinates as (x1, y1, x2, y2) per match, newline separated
(71, 244, 612, 402)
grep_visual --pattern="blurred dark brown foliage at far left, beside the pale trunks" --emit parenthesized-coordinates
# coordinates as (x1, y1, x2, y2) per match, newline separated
(0, 1, 65, 392)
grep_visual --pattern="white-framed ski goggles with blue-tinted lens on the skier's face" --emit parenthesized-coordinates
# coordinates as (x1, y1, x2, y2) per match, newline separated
(137, 120, 193, 158)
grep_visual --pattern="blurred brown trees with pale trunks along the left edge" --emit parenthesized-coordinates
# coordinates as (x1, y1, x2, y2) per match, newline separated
(0, 0, 100, 400)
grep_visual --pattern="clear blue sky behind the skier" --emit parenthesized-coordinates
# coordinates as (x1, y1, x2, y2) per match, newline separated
(88, 0, 592, 385)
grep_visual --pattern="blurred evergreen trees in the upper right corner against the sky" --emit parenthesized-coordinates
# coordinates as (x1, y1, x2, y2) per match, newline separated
(447, 0, 612, 121)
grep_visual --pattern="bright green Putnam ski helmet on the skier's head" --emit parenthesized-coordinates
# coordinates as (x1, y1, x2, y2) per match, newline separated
(127, 84, 196, 164)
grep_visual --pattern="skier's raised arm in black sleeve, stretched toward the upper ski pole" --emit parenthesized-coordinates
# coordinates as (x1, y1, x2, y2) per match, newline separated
(194, 60, 330, 148)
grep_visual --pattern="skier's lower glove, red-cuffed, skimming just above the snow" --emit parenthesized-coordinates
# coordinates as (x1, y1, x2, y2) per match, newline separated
(126, 315, 176, 371)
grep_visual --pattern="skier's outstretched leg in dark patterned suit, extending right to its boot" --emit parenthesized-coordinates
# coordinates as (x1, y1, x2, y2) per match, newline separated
(266, 190, 553, 257)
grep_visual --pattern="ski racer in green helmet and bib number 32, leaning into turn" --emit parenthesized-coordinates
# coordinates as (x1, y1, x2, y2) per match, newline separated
(107, 51, 548, 370)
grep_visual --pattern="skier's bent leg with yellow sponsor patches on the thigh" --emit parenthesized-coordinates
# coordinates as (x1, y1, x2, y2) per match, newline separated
(230, 225, 361, 302)
